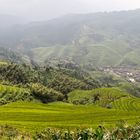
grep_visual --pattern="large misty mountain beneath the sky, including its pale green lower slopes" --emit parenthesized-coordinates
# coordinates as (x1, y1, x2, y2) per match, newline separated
(0, 9, 140, 67)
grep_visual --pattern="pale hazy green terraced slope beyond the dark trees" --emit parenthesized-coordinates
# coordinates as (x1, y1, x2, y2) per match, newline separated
(32, 39, 135, 67)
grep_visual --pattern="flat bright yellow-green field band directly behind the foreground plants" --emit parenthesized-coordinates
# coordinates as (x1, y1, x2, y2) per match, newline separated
(0, 102, 140, 132)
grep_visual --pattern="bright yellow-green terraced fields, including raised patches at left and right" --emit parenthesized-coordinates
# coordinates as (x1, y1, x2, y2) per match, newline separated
(0, 85, 140, 132)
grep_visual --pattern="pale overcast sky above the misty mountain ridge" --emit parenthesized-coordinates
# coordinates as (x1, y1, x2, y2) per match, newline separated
(0, 0, 140, 21)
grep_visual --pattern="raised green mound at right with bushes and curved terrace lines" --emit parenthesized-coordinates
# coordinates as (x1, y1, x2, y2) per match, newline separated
(69, 88, 140, 111)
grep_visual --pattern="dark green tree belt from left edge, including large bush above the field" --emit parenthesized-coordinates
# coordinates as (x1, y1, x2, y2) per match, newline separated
(0, 61, 99, 104)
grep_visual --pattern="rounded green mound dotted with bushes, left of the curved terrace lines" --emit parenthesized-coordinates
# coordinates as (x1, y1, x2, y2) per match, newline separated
(68, 88, 129, 108)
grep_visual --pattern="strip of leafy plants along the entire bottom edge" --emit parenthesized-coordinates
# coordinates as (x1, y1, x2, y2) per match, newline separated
(0, 121, 140, 140)
